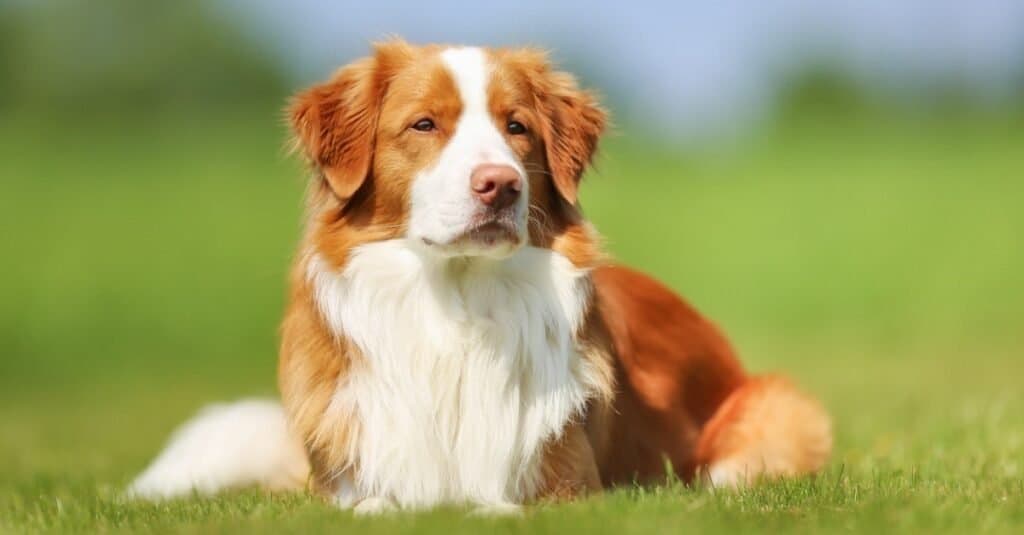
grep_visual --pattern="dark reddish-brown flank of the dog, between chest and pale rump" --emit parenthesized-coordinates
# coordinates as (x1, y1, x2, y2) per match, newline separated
(594, 266, 744, 484)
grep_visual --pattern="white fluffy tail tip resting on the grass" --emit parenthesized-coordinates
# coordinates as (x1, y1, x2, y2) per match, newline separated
(128, 400, 309, 499)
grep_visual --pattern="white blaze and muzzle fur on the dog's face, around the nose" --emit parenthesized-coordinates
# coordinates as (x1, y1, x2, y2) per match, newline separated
(409, 47, 529, 256)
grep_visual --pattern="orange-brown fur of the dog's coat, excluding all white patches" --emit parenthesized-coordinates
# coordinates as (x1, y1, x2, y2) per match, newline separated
(280, 41, 827, 499)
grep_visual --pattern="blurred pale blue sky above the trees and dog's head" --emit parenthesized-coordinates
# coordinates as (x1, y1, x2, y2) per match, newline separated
(220, 0, 1024, 133)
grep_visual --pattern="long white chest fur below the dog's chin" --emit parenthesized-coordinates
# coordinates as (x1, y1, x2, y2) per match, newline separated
(309, 240, 597, 507)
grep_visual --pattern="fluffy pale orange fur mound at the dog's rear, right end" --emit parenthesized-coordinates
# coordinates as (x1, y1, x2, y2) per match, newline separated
(696, 376, 833, 487)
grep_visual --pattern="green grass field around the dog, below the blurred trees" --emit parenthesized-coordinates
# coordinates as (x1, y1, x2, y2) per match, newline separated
(0, 112, 1024, 534)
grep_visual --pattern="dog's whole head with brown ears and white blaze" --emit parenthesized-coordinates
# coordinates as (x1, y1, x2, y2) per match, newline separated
(291, 41, 605, 257)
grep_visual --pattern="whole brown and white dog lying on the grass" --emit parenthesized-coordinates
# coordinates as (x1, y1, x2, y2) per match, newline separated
(132, 41, 831, 511)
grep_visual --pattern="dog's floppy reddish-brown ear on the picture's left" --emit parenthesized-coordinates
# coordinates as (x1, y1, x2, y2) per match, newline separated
(288, 40, 413, 203)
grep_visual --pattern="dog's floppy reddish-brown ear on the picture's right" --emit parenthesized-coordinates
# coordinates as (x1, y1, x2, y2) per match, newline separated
(520, 49, 607, 206)
